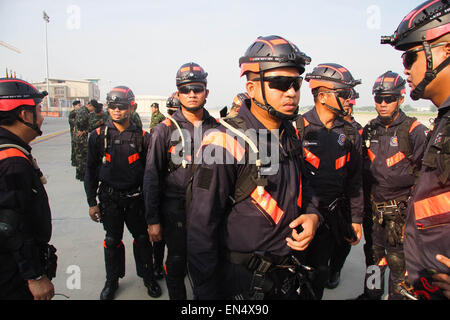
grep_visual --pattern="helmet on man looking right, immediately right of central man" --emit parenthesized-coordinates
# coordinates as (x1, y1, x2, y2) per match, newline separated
(305, 63, 361, 90)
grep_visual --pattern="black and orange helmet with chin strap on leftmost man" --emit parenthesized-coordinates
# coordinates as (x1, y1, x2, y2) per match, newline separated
(0, 78, 48, 135)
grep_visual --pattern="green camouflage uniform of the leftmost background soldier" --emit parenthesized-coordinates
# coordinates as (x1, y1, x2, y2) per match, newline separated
(73, 106, 90, 181)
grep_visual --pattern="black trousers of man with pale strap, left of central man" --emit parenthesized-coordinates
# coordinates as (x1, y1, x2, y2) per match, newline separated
(161, 199, 187, 300)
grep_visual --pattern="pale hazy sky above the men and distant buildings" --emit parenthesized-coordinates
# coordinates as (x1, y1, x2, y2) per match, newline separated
(0, 0, 431, 109)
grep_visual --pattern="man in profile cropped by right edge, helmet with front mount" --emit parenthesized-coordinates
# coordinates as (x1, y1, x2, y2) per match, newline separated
(381, 0, 450, 299)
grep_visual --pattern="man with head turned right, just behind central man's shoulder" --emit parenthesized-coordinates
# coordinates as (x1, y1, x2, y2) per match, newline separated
(296, 63, 364, 299)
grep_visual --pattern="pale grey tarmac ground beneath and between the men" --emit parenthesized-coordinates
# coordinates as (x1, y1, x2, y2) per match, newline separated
(31, 112, 432, 300)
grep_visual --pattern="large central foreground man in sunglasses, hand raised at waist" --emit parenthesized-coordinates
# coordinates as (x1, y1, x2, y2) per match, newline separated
(188, 35, 320, 300)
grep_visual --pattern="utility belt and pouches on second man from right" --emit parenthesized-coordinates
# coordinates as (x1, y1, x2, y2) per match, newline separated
(371, 196, 408, 246)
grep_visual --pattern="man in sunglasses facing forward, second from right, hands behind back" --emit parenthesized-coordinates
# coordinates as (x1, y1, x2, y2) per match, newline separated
(359, 71, 428, 299)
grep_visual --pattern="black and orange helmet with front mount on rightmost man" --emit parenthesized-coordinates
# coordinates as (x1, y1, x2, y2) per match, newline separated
(381, 0, 450, 51)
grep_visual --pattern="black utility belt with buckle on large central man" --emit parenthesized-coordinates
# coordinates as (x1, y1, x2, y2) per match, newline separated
(226, 252, 315, 300)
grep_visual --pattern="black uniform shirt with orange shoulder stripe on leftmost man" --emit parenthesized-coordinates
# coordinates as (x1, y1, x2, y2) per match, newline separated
(0, 127, 52, 279)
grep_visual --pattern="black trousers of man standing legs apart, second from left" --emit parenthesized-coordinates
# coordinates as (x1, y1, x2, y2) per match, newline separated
(99, 187, 154, 281)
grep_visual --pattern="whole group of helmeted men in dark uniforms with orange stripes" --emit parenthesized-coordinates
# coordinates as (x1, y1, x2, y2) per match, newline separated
(0, 0, 450, 300)
